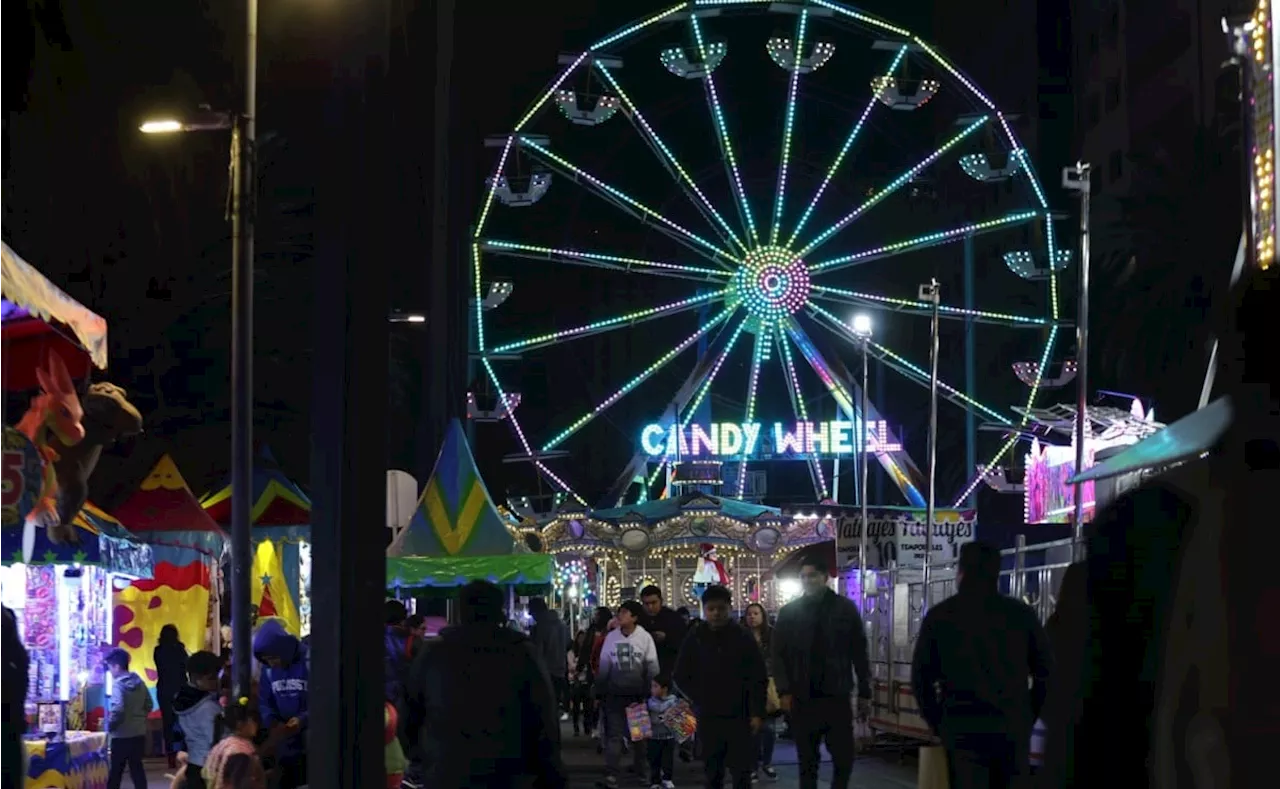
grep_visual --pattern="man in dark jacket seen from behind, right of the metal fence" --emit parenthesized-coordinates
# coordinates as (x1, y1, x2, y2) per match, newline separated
(911, 542, 1052, 789)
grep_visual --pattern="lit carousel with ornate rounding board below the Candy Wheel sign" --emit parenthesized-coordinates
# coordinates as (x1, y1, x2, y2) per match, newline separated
(540, 492, 831, 610)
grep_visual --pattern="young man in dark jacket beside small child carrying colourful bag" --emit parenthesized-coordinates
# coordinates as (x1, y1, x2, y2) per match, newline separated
(672, 585, 768, 789)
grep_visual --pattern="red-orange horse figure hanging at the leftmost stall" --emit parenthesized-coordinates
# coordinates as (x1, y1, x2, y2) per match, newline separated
(17, 351, 84, 562)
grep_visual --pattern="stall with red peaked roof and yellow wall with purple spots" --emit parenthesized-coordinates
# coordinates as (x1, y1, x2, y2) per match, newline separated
(111, 455, 227, 689)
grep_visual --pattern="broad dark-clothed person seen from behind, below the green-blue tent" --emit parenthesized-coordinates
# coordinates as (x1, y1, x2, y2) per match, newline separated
(399, 582, 564, 789)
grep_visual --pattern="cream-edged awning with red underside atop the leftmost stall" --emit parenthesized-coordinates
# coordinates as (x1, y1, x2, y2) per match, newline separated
(0, 241, 106, 391)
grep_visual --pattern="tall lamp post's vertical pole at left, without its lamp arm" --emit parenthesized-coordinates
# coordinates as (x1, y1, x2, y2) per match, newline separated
(232, 0, 257, 697)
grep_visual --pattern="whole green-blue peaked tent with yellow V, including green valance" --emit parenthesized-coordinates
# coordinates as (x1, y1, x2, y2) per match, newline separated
(387, 420, 554, 615)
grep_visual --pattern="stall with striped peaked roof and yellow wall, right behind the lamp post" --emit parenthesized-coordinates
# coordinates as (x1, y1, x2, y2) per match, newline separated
(200, 447, 311, 638)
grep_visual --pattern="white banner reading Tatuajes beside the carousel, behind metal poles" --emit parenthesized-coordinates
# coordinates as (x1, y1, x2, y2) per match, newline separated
(820, 506, 977, 570)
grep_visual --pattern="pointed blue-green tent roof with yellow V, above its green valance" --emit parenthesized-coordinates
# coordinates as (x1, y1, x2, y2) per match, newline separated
(387, 419, 513, 556)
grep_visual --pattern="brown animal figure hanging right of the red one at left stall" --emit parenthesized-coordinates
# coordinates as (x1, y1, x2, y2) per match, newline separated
(49, 382, 142, 543)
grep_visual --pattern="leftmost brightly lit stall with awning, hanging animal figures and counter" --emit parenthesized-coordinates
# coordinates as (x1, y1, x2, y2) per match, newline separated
(0, 242, 151, 789)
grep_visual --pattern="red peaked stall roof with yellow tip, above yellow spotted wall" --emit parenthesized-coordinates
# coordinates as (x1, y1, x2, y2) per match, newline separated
(114, 453, 224, 551)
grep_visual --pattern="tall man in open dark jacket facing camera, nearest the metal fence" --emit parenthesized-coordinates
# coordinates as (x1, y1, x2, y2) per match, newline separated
(772, 552, 872, 789)
